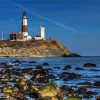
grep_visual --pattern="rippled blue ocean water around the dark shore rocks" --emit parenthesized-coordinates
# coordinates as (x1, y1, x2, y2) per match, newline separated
(0, 57, 100, 100)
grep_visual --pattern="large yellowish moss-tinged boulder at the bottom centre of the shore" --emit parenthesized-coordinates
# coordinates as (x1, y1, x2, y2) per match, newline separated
(38, 82, 63, 100)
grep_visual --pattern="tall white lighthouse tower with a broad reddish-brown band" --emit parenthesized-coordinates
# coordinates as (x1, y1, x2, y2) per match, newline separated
(22, 12, 28, 40)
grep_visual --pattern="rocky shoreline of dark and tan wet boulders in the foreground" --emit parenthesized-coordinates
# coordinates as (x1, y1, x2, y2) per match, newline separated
(0, 60, 100, 100)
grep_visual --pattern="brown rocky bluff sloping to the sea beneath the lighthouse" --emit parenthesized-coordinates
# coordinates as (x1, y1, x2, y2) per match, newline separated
(0, 40, 78, 57)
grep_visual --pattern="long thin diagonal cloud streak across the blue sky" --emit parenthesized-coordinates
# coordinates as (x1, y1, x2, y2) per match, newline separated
(8, 0, 80, 33)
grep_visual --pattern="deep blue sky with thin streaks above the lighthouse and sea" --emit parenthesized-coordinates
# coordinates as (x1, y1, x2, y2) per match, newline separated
(0, 0, 100, 56)
